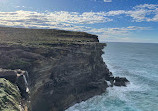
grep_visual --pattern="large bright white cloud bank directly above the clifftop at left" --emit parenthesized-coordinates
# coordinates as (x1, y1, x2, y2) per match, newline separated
(0, 10, 112, 31)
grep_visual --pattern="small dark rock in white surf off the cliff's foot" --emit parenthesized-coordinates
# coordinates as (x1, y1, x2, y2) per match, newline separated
(114, 77, 129, 86)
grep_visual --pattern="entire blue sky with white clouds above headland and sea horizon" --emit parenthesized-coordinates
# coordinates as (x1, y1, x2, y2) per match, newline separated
(0, 0, 158, 43)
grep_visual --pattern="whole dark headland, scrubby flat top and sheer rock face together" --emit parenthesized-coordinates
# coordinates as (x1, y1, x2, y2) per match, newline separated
(0, 28, 112, 111)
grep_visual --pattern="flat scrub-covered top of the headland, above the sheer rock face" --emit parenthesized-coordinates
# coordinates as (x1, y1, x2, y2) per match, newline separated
(0, 27, 99, 46)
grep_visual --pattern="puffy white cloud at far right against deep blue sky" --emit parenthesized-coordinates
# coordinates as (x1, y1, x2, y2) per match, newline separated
(105, 4, 158, 22)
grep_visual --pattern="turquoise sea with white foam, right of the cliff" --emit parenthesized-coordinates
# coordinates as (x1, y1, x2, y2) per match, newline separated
(66, 43, 158, 111)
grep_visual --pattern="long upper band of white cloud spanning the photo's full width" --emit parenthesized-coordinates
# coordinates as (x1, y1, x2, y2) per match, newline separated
(0, 4, 158, 28)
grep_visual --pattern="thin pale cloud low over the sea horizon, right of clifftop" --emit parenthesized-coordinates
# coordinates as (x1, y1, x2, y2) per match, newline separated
(95, 26, 151, 42)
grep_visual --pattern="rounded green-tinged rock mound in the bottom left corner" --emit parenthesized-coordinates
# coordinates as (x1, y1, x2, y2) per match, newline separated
(0, 78, 21, 111)
